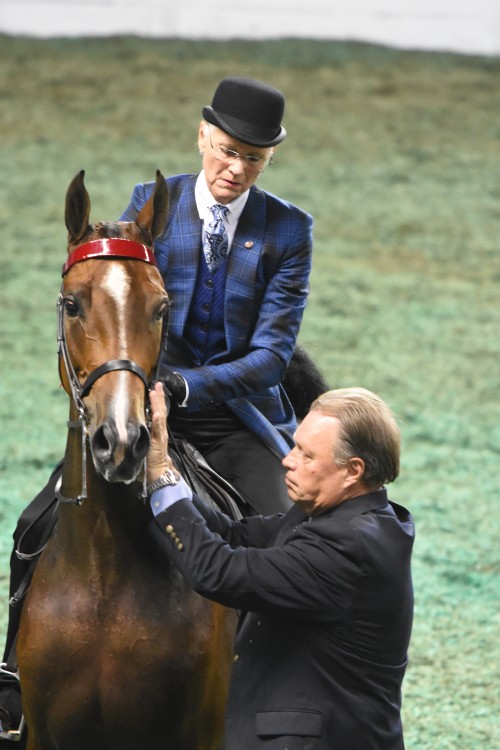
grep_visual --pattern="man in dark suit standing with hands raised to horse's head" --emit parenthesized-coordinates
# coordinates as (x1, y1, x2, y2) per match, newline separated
(148, 387, 415, 750)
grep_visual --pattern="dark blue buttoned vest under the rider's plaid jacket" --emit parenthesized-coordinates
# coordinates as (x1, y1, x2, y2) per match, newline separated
(184, 252, 227, 367)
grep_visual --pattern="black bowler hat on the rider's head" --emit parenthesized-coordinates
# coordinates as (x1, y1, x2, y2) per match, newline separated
(203, 77, 286, 148)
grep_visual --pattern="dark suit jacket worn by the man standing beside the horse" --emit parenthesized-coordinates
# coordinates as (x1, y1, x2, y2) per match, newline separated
(150, 489, 414, 750)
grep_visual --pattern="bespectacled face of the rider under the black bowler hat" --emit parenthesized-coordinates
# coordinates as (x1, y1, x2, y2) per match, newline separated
(198, 122, 272, 205)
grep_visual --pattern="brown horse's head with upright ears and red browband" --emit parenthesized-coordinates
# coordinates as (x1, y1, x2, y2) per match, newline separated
(59, 171, 168, 483)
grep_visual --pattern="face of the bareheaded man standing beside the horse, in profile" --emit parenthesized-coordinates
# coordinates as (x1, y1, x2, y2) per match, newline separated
(283, 411, 364, 516)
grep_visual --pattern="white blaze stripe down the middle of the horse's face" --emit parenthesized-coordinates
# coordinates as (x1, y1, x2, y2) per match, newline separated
(101, 263, 132, 452)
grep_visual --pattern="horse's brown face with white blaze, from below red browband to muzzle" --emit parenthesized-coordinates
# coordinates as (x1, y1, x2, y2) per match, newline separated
(63, 258, 168, 484)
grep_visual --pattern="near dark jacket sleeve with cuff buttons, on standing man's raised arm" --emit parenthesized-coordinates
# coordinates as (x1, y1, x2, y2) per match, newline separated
(146, 500, 370, 620)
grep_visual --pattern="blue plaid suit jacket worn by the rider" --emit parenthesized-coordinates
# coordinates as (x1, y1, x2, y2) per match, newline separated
(121, 175, 312, 457)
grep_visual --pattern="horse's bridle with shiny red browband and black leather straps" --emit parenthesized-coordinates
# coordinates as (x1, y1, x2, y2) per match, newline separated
(56, 238, 169, 505)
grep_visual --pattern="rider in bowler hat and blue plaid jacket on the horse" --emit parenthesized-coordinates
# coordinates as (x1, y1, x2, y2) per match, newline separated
(0, 77, 316, 740)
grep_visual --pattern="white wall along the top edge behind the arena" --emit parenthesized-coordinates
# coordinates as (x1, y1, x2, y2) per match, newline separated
(0, 0, 500, 55)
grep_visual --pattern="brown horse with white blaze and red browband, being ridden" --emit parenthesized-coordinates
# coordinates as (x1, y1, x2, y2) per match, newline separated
(17, 171, 236, 750)
